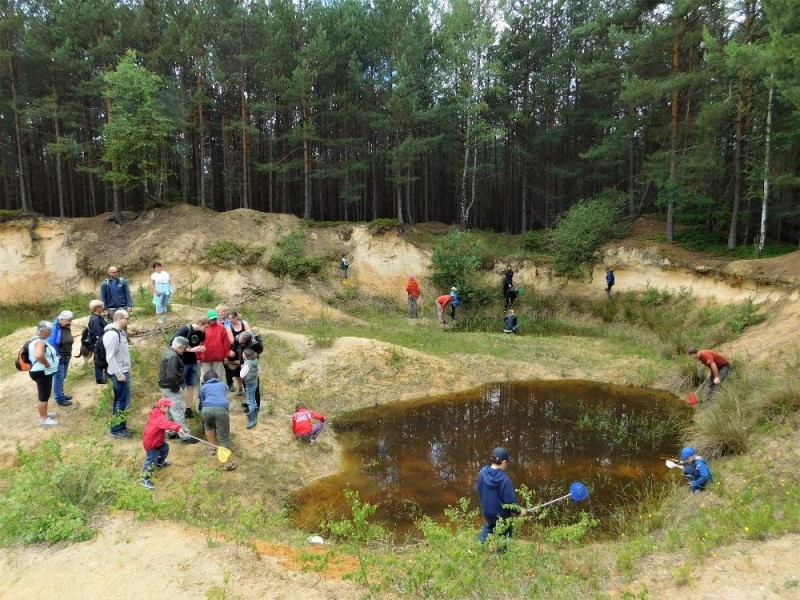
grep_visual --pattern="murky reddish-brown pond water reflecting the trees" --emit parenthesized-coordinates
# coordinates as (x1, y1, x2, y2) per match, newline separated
(292, 381, 689, 533)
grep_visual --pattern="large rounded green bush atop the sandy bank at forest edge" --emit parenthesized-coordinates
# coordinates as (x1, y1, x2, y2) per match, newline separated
(550, 191, 627, 275)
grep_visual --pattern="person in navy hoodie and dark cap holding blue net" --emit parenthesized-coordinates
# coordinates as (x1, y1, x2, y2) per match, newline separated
(477, 448, 527, 542)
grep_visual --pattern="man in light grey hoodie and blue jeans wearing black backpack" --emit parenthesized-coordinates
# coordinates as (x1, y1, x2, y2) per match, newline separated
(103, 309, 133, 440)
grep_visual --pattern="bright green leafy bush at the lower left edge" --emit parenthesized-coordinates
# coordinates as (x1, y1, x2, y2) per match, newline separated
(0, 439, 134, 546)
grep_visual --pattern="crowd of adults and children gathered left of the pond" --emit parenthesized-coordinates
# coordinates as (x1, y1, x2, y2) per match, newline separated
(27, 262, 325, 489)
